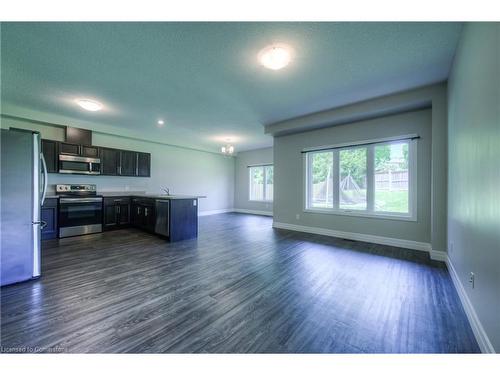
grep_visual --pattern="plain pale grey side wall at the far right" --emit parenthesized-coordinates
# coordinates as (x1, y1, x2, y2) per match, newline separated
(448, 23, 500, 352)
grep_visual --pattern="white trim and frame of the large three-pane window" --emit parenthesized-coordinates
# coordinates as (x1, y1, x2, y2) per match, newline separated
(302, 137, 418, 221)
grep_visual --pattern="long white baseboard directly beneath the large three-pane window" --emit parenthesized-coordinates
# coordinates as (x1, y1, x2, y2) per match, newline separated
(273, 222, 431, 252)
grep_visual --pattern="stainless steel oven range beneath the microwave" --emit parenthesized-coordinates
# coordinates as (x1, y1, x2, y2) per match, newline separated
(56, 185, 102, 237)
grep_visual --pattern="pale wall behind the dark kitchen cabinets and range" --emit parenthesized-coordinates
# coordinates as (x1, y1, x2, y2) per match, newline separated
(1, 118, 235, 212)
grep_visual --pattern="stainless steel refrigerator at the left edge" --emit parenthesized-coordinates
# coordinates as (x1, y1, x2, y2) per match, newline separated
(0, 129, 47, 286)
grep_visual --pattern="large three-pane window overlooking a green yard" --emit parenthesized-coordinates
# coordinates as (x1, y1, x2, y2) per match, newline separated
(305, 140, 416, 220)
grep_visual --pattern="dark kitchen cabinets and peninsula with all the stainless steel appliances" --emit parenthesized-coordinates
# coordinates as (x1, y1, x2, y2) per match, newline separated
(1, 127, 205, 286)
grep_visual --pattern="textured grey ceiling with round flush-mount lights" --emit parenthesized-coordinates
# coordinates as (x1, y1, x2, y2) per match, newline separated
(1, 22, 462, 151)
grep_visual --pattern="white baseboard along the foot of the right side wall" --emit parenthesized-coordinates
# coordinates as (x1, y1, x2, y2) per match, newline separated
(446, 256, 495, 354)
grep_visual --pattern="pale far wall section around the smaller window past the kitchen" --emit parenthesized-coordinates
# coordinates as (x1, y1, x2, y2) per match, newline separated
(234, 147, 273, 214)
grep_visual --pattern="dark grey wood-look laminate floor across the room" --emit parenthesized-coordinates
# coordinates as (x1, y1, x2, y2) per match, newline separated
(1, 214, 479, 353)
